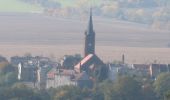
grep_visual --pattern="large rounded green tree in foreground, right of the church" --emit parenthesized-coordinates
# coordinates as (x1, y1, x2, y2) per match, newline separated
(113, 76, 142, 100)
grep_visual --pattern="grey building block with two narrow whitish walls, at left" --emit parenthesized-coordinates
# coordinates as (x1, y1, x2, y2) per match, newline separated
(11, 56, 57, 88)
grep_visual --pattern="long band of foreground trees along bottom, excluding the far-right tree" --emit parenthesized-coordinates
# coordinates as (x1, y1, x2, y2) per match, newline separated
(0, 73, 169, 100)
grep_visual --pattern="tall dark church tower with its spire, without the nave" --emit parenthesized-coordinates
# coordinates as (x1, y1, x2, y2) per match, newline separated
(84, 9, 95, 57)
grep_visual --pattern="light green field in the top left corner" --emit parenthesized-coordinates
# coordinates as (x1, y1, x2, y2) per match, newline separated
(0, 0, 43, 12)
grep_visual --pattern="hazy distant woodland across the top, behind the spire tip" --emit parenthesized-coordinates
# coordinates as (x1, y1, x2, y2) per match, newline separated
(20, 0, 170, 29)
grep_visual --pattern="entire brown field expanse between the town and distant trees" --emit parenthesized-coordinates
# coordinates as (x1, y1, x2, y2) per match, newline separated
(0, 14, 170, 63)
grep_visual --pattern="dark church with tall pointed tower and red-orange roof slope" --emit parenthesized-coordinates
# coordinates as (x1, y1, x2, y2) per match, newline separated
(74, 9, 107, 80)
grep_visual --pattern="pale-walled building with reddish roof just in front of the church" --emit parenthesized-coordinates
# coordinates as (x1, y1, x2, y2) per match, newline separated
(46, 69, 93, 88)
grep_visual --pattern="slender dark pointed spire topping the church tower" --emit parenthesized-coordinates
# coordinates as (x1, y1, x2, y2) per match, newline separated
(87, 8, 94, 34)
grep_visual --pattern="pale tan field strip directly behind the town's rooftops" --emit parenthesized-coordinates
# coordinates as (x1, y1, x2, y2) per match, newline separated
(0, 44, 170, 64)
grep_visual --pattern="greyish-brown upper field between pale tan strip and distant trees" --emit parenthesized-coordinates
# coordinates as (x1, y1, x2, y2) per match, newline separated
(0, 14, 170, 47)
